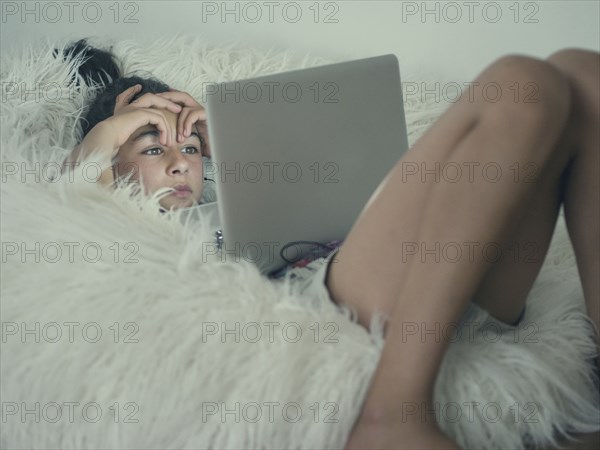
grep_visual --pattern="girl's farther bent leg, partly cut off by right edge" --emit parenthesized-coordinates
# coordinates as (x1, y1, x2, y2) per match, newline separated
(472, 49, 600, 449)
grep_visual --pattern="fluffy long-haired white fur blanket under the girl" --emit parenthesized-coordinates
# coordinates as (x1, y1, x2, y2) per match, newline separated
(1, 36, 599, 449)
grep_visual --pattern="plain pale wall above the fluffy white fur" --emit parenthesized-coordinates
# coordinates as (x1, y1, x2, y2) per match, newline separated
(0, 0, 600, 81)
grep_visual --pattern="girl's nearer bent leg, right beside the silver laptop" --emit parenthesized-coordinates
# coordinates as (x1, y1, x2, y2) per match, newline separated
(329, 51, 596, 447)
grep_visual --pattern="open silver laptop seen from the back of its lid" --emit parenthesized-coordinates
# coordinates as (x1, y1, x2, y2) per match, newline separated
(199, 54, 408, 274)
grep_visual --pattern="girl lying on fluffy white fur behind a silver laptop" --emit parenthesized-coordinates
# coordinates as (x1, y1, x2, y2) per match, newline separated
(59, 41, 600, 449)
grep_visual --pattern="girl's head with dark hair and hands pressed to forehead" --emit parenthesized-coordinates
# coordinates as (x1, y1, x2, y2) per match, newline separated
(64, 39, 210, 209)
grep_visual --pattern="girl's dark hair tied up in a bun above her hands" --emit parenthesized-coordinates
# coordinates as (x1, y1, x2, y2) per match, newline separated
(54, 39, 169, 139)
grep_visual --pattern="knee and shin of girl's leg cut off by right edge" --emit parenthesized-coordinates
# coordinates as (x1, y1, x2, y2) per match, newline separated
(548, 49, 600, 449)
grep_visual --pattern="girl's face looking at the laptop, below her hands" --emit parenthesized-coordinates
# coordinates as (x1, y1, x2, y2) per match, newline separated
(115, 110, 204, 209)
